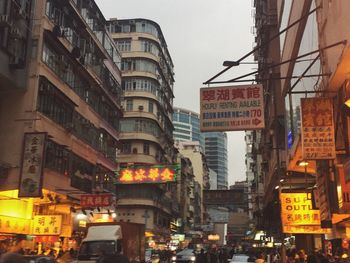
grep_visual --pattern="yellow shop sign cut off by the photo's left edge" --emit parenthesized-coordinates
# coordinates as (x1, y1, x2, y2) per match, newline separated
(0, 216, 31, 235)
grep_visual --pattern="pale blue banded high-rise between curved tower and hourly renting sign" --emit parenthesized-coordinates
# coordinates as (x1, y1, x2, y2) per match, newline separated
(173, 108, 205, 150)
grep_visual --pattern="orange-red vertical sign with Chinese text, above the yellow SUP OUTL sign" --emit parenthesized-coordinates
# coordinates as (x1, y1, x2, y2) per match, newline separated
(301, 98, 335, 160)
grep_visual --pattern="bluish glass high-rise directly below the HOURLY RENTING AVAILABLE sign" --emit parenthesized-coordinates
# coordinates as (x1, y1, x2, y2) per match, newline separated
(204, 132, 228, 190)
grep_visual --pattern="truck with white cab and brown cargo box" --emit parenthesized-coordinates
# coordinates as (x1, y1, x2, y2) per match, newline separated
(77, 222, 145, 263)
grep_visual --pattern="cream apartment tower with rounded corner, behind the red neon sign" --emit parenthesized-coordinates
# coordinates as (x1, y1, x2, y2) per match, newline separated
(109, 19, 179, 241)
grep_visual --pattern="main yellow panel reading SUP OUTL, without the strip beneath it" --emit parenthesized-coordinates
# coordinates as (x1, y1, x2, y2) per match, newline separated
(280, 193, 320, 226)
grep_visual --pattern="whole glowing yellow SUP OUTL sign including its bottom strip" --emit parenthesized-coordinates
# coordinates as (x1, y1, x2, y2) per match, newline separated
(280, 193, 330, 233)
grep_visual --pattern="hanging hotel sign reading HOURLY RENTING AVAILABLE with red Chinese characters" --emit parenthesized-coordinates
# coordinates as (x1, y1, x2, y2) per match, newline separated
(200, 84, 265, 132)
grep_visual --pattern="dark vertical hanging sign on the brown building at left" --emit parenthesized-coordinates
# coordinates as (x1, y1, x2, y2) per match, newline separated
(18, 133, 47, 197)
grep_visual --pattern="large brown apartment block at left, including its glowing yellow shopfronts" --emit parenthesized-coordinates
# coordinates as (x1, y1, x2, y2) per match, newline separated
(0, 0, 122, 252)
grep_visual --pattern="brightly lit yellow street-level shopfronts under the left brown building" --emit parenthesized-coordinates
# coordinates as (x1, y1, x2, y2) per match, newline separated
(0, 189, 116, 254)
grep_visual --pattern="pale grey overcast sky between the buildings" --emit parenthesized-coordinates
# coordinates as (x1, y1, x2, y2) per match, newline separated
(95, 0, 254, 185)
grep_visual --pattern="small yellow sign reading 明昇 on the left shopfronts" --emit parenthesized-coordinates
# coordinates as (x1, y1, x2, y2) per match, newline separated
(33, 215, 62, 235)
